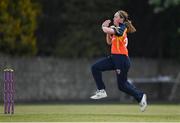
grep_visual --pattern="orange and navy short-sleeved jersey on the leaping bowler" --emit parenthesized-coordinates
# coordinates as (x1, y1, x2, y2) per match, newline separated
(111, 24, 128, 56)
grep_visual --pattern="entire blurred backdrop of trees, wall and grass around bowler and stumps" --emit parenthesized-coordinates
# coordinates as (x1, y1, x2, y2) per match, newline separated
(0, 0, 180, 122)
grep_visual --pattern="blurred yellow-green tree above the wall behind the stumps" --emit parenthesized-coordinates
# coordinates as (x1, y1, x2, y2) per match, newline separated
(0, 0, 40, 56)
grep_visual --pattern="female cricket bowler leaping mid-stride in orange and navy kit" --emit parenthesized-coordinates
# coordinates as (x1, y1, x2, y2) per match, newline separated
(90, 10, 147, 112)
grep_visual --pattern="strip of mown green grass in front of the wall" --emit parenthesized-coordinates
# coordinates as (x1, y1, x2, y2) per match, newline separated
(0, 104, 180, 122)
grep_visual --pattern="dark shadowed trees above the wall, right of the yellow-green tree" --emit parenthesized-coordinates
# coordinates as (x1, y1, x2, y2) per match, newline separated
(37, 0, 180, 58)
